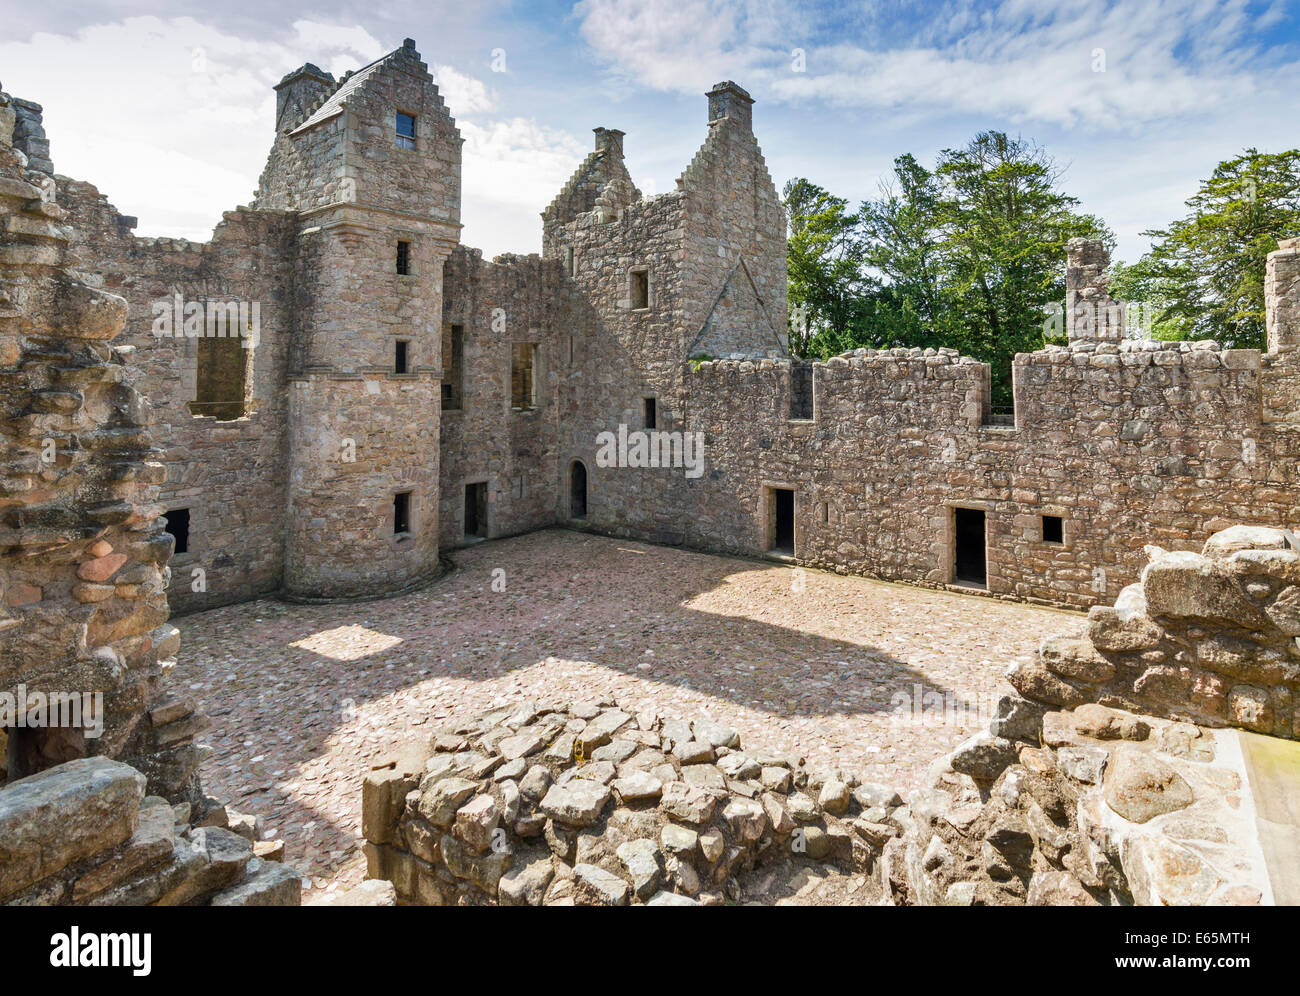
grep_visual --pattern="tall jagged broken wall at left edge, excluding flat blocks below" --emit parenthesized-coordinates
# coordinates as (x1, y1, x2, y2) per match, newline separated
(0, 94, 204, 800)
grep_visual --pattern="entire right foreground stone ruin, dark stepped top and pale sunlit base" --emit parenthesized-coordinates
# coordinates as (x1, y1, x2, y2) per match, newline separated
(879, 527, 1300, 906)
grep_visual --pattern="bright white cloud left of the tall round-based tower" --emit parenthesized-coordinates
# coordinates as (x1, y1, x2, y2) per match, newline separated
(0, 17, 382, 239)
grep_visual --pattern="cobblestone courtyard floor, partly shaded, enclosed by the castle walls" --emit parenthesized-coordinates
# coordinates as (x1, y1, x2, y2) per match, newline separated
(177, 531, 1079, 901)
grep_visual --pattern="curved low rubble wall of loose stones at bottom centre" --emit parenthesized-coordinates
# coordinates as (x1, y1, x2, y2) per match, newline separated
(361, 700, 905, 906)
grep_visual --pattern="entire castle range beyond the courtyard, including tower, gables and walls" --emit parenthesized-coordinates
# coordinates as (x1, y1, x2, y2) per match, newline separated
(12, 40, 1300, 624)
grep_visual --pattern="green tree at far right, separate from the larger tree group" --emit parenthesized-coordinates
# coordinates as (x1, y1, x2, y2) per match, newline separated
(1112, 148, 1300, 350)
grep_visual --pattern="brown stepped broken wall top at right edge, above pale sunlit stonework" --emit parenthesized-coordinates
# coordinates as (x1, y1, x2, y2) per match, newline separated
(1010, 525, 1300, 740)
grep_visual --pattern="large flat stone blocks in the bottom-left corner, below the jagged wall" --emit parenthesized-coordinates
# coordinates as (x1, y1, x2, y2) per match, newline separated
(0, 757, 302, 906)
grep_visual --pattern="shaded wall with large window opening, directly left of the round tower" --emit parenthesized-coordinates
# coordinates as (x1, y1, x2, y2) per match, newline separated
(60, 178, 294, 612)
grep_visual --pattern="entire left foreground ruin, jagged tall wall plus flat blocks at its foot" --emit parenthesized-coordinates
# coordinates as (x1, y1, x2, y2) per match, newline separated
(0, 85, 299, 906)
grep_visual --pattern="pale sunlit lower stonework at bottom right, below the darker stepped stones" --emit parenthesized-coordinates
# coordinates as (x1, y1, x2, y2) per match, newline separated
(880, 700, 1270, 906)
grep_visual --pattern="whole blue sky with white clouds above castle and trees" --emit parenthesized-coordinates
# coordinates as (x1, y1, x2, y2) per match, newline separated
(0, 0, 1300, 260)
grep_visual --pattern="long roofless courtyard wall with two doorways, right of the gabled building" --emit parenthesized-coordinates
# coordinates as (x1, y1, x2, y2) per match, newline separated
(681, 341, 1300, 606)
